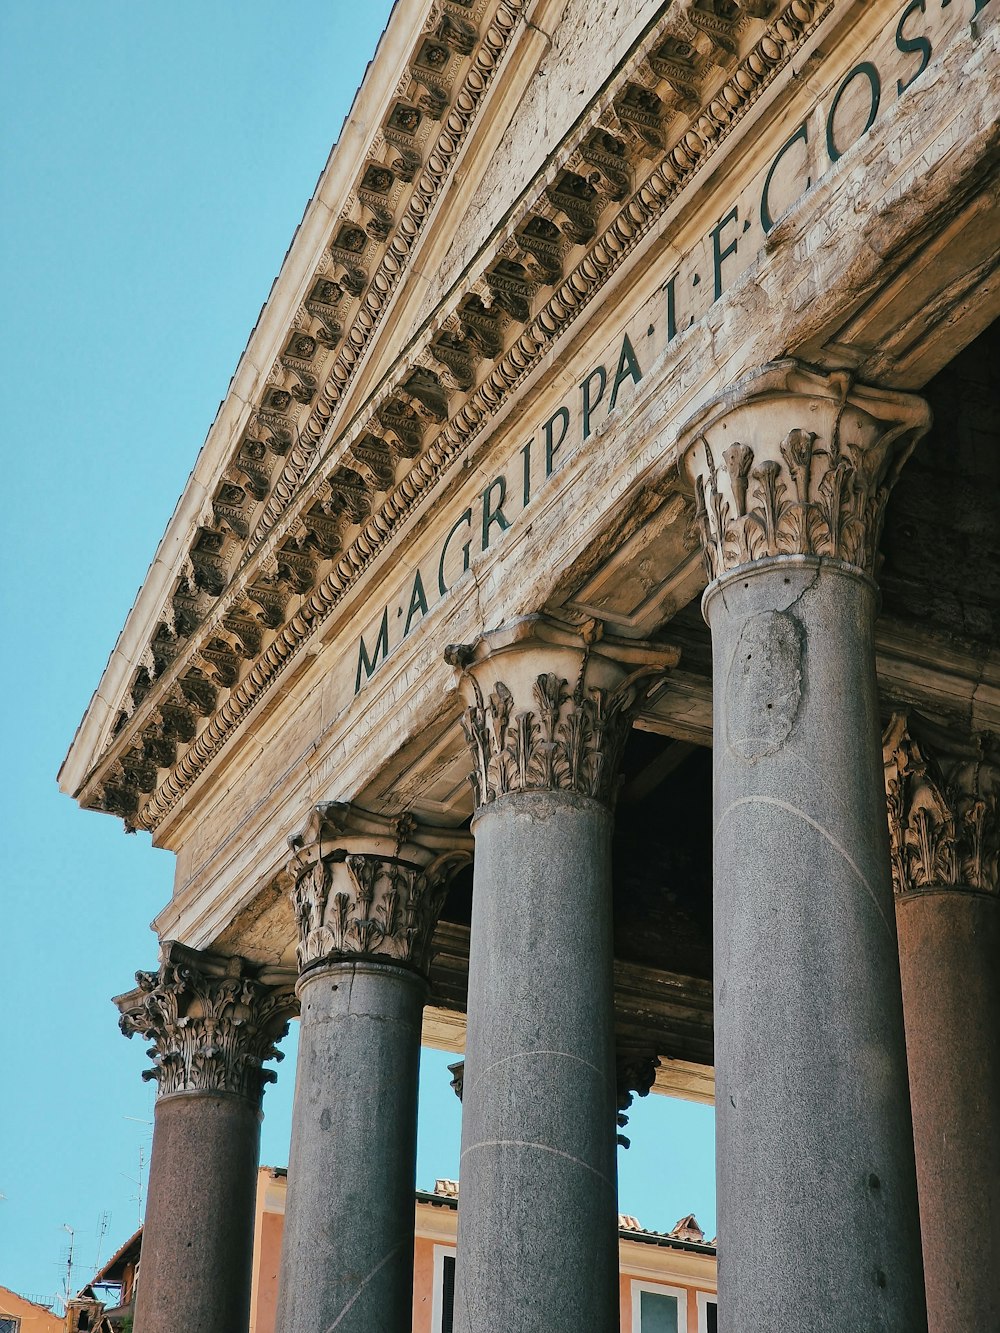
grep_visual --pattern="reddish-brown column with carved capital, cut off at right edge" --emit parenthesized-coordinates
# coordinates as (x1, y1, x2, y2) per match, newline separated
(883, 714, 1000, 1333)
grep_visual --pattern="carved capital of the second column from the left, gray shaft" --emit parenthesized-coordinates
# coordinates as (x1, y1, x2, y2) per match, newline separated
(288, 801, 472, 976)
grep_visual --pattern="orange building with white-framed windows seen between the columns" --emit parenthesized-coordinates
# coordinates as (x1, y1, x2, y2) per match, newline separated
(249, 1166, 716, 1333)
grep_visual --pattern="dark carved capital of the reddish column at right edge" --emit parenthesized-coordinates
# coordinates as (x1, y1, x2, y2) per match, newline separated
(883, 713, 1000, 893)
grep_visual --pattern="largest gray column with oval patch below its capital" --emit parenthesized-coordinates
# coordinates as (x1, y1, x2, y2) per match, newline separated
(680, 361, 929, 1333)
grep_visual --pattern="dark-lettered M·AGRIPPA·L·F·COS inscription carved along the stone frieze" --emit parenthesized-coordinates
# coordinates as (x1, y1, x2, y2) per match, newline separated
(355, 0, 989, 693)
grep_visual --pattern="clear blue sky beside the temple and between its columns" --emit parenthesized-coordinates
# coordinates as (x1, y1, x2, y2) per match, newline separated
(0, 0, 715, 1298)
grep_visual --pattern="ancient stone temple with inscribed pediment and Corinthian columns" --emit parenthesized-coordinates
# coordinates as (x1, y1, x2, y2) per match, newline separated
(61, 0, 1000, 1333)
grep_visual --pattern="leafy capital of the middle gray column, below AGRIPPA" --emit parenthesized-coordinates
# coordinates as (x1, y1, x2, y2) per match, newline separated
(445, 616, 680, 808)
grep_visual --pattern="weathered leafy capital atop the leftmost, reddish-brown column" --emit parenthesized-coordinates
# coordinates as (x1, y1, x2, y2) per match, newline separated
(115, 942, 295, 1105)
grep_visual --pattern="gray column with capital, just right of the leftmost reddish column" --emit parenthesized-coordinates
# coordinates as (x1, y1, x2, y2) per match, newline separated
(277, 801, 472, 1333)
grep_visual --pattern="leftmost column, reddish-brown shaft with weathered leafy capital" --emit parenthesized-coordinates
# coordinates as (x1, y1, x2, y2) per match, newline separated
(115, 944, 293, 1333)
